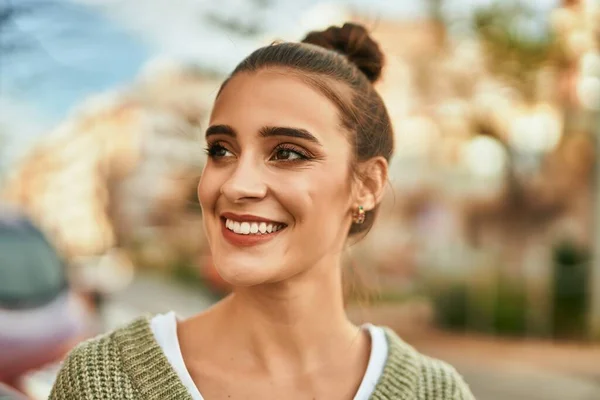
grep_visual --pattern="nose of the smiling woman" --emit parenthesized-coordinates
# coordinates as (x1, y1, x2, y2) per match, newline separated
(221, 157, 267, 203)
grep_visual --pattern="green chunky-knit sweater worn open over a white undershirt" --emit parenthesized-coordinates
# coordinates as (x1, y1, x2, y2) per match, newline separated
(50, 316, 474, 400)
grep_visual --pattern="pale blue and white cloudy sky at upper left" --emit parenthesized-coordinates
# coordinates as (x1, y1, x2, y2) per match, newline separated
(0, 0, 555, 159)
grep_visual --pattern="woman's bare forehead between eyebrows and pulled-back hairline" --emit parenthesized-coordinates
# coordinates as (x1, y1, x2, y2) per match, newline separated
(210, 70, 342, 140)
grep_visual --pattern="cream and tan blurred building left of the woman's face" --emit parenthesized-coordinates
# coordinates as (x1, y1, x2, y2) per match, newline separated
(3, 65, 218, 257)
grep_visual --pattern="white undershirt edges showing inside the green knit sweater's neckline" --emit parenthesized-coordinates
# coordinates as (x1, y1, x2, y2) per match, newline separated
(150, 311, 388, 400)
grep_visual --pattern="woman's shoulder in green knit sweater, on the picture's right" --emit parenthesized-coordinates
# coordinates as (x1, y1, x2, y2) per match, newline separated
(376, 328, 474, 400)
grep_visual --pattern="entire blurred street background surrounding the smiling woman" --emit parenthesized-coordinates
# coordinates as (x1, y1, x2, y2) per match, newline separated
(0, 0, 600, 400)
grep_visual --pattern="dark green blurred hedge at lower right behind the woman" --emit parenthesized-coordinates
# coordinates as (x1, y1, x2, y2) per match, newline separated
(428, 241, 590, 340)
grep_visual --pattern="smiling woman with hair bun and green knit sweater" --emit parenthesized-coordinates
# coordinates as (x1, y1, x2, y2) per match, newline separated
(51, 24, 472, 400)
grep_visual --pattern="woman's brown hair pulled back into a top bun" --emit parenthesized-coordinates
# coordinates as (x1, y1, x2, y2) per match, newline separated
(221, 23, 394, 234)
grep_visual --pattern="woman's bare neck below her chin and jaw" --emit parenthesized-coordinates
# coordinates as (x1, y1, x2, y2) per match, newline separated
(209, 256, 363, 373)
